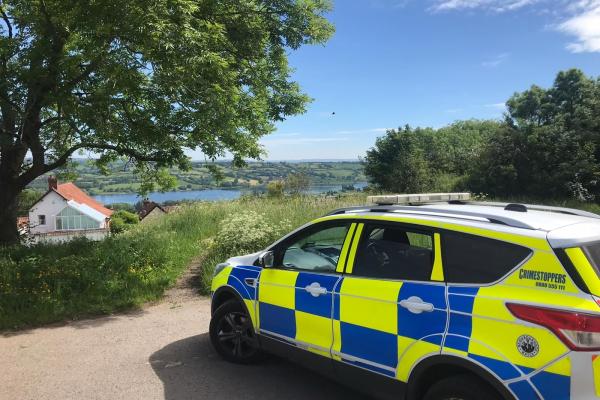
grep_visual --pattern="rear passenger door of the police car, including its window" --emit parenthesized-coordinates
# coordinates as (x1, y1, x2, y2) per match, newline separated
(332, 221, 447, 382)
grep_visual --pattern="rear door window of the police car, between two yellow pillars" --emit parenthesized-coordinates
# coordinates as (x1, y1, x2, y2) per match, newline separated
(352, 223, 434, 281)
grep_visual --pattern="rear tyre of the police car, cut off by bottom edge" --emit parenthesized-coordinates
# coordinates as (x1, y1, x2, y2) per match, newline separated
(423, 374, 502, 400)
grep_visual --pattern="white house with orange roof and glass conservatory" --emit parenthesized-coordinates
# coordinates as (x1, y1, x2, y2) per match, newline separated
(29, 176, 112, 242)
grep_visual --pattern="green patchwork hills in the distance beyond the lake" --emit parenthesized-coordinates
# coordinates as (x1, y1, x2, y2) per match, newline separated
(30, 159, 366, 195)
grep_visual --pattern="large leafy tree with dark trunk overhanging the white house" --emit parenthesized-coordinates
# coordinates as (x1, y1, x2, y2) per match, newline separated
(0, 0, 333, 244)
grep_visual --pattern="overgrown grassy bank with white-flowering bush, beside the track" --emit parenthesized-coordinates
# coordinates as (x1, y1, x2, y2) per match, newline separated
(0, 195, 364, 329)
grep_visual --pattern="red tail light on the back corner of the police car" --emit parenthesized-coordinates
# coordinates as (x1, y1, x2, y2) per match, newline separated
(506, 303, 600, 351)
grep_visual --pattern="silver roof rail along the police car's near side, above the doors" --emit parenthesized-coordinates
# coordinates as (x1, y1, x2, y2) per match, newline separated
(327, 205, 535, 229)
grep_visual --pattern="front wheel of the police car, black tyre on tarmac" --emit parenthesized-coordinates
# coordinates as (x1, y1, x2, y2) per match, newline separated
(210, 300, 261, 364)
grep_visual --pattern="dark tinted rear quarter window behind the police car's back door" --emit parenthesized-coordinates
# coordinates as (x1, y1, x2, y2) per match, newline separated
(441, 232, 531, 284)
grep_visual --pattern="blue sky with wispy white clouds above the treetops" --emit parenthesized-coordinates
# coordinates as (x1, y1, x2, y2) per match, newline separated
(190, 0, 600, 160)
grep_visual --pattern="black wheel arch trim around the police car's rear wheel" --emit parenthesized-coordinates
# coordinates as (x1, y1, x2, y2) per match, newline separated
(406, 355, 515, 400)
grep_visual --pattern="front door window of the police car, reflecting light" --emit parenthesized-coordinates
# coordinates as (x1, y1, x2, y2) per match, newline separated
(275, 222, 350, 272)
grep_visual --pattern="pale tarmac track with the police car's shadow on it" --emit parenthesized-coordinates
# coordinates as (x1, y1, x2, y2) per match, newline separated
(0, 271, 362, 400)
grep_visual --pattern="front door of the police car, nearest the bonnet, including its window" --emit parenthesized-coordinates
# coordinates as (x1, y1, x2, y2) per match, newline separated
(257, 221, 356, 358)
